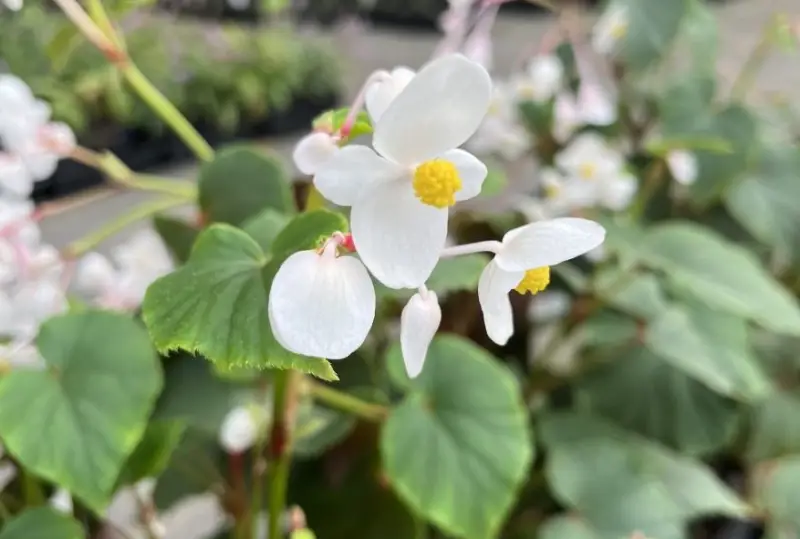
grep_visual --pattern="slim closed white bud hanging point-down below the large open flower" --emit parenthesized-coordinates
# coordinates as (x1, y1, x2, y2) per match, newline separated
(400, 290, 442, 378)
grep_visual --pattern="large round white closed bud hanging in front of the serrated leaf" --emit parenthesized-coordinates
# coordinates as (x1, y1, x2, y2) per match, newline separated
(269, 251, 375, 359)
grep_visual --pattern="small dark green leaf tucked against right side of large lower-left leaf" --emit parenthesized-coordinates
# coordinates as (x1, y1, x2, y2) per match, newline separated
(118, 421, 186, 485)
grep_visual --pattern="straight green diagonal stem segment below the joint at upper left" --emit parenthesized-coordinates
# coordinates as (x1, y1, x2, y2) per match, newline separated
(119, 62, 214, 161)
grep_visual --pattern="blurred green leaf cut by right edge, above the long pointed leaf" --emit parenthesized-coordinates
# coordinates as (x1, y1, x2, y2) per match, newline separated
(725, 145, 800, 260)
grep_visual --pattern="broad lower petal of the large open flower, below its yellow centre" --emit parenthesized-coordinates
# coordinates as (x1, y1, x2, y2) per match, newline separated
(350, 182, 448, 288)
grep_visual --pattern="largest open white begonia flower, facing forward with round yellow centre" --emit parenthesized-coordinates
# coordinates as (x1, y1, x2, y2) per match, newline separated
(314, 54, 491, 288)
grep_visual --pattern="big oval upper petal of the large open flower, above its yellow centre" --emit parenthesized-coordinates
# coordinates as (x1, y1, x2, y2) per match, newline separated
(373, 54, 492, 165)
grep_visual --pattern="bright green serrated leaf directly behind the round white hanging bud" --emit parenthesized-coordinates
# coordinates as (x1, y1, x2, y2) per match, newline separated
(142, 224, 336, 380)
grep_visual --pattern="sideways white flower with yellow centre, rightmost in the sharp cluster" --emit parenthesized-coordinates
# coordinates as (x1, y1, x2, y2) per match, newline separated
(478, 217, 605, 346)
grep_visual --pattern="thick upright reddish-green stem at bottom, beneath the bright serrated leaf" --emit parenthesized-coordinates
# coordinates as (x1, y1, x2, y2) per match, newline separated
(268, 370, 293, 539)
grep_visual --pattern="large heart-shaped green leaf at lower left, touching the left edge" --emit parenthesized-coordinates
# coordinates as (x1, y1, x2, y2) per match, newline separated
(0, 311, 161, 512)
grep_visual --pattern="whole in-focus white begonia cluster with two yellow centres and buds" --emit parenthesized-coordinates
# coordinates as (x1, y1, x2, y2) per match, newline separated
(276, 54, 605, 377)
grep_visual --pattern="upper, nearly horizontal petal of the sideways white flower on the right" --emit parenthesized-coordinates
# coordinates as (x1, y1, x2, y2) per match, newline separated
(495, 217, 606, 271)
